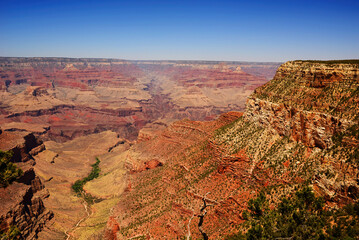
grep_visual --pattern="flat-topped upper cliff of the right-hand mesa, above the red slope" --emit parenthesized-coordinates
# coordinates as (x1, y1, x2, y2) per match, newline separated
(245, 61, 359, 148)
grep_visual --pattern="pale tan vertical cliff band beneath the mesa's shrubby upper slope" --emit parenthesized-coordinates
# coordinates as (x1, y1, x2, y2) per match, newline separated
(245, 98, 352, 149)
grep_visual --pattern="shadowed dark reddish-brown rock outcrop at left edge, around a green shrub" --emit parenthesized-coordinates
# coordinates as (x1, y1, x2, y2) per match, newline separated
(0, 131, 53, 239)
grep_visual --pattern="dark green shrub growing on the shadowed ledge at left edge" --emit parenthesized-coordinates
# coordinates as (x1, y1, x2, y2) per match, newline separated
(0, 150, 22, 187)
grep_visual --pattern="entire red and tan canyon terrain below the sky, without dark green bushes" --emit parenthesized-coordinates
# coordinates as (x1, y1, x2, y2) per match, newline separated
(0, 59, 359, 239)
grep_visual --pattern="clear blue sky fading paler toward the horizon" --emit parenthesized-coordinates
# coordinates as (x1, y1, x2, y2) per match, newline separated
(0, 0, 359, 61)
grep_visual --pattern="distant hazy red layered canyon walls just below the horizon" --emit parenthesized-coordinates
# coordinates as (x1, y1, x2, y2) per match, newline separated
(0, 58, 278, 142)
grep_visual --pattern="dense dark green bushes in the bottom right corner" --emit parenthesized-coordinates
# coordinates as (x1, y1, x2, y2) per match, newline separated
(226, 186, 359, 240)
